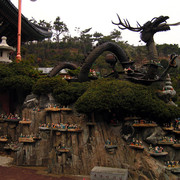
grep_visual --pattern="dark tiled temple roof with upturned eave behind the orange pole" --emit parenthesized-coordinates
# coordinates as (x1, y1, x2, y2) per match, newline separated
(0, 0, 52, 46)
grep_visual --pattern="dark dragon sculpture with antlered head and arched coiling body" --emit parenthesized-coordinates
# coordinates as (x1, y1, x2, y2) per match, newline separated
(50, 15, 180, 84)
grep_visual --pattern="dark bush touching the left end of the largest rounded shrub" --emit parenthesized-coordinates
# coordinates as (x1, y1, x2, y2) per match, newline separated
(53, 82, 89, 105)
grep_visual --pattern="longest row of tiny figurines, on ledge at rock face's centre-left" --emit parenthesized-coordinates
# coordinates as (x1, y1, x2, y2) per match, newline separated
(40, 123, 78, 129)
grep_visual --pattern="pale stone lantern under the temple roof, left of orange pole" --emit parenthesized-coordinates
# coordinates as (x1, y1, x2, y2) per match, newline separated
(0, 36, 15, 63)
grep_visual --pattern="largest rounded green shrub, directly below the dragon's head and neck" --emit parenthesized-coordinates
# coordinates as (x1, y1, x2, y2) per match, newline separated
(75, 79, 180, 121)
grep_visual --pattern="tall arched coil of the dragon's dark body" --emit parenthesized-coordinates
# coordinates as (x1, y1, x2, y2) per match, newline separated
(79, 42, 133, 82)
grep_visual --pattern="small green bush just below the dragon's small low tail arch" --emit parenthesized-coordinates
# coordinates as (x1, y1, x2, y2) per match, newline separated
(33, 76, 67, 95)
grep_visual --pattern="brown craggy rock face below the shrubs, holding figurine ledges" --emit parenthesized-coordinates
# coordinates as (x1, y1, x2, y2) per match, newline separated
(0, 96, 180, 180)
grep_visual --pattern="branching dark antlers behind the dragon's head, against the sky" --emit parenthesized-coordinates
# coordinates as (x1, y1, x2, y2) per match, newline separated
(112, 14, 142, 32)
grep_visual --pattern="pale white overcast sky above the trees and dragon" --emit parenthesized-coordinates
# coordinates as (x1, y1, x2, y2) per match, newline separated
(11, 0, 180, 46)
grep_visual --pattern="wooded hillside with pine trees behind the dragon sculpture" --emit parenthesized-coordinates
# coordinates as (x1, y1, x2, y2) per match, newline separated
(18, 16, 180, 70)
